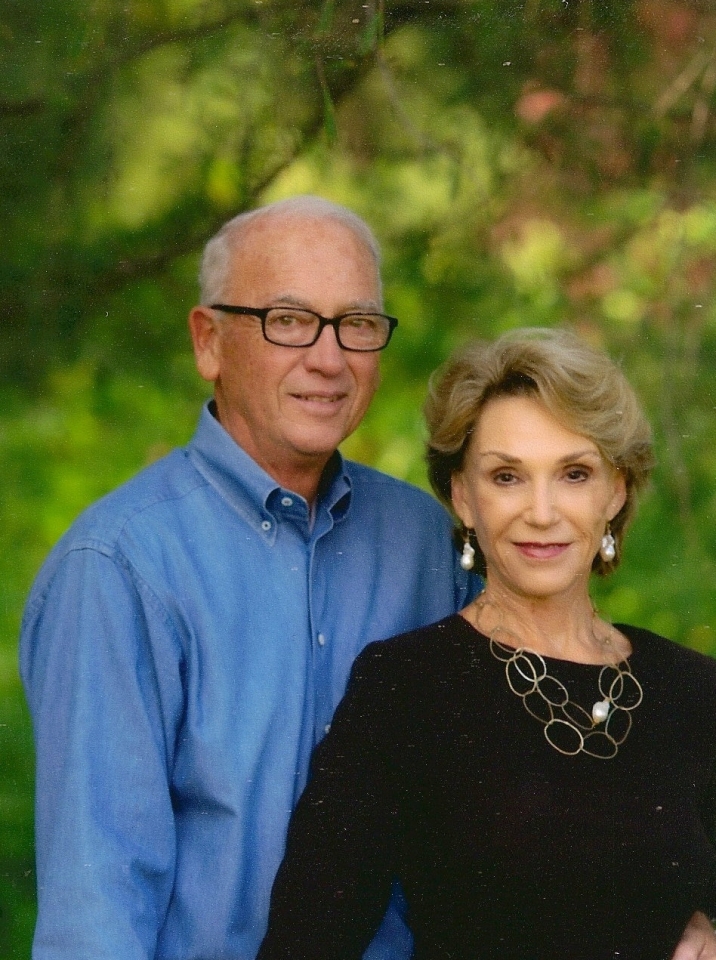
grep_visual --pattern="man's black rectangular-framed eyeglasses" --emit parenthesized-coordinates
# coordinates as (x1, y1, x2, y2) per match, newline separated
(211, 303, 398, 353)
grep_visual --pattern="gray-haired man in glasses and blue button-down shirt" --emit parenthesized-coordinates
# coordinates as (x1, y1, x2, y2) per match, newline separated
(21, 198, 708, 960)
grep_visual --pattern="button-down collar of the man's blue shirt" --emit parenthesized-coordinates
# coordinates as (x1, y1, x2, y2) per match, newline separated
(187, 400, 351, 539)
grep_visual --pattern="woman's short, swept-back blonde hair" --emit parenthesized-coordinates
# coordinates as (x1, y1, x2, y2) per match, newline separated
(425, 327, 654, 574)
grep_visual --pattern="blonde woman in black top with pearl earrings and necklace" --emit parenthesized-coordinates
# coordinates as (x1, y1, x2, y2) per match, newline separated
(259, 330, 716, 960)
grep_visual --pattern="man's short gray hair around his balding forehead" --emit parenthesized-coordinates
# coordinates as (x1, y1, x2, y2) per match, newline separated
(199, 194, 380, 306)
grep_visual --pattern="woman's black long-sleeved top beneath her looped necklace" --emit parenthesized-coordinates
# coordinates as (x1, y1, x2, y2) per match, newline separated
(259, 616, 716, 960)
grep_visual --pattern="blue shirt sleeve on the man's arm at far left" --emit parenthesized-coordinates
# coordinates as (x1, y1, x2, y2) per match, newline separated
(21, 549, 181, 960)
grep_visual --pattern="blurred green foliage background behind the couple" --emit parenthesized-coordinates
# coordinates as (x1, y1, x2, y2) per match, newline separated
(0, 0, 716, 957)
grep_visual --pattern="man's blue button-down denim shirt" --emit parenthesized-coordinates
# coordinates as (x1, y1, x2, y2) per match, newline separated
(21, 408, 474, 960)
